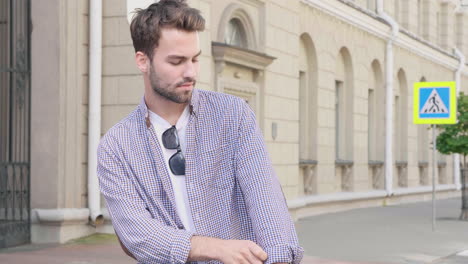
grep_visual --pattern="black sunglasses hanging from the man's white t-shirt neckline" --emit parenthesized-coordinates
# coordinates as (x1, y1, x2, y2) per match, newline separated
(162, 126, 185, 175)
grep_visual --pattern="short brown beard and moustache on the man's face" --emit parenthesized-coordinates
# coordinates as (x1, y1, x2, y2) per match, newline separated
(149, 64, 196, 104)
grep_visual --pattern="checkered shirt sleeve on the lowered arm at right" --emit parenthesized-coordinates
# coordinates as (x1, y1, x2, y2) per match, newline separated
(236, 104, 304, 264)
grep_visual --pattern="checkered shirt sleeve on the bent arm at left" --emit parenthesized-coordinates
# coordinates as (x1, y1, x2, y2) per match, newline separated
(97, 135, 193, 263)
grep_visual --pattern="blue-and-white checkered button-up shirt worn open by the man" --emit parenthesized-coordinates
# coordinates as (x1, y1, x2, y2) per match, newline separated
(98, 89, 303, 263)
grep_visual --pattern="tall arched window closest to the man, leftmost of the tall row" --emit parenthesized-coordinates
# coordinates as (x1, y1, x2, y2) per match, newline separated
(299, 34, 318, 195)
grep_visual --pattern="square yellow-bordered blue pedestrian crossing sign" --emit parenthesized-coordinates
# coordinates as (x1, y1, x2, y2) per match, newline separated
(413, 82, 457, 124)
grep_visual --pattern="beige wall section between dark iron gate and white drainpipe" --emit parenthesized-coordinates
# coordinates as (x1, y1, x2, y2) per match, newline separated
(31, 0, 93, 243)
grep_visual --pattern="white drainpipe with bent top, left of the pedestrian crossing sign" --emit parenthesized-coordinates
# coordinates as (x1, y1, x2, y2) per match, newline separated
(376, 0, 399, 196)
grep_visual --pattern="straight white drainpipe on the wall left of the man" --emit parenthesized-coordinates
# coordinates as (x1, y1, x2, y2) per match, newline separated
(88, 0, 104, 225)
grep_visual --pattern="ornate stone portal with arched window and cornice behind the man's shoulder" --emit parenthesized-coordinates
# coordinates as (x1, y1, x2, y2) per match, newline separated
(211, 3, 270, 128)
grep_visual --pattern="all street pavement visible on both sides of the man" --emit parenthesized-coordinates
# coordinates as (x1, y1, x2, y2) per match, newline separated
(0, 198, 468, 264)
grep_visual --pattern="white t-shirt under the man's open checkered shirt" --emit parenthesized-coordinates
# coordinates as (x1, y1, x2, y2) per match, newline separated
(149, 106, 195, 232)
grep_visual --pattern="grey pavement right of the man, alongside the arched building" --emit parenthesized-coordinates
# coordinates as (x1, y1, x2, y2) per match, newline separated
(296, 198, 468, 264)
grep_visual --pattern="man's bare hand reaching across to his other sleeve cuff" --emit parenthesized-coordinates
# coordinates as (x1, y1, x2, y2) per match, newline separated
(188, 236, 268, 264)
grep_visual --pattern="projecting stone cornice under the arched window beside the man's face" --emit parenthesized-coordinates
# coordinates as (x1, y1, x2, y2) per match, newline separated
(211, 42, 276, 70)
